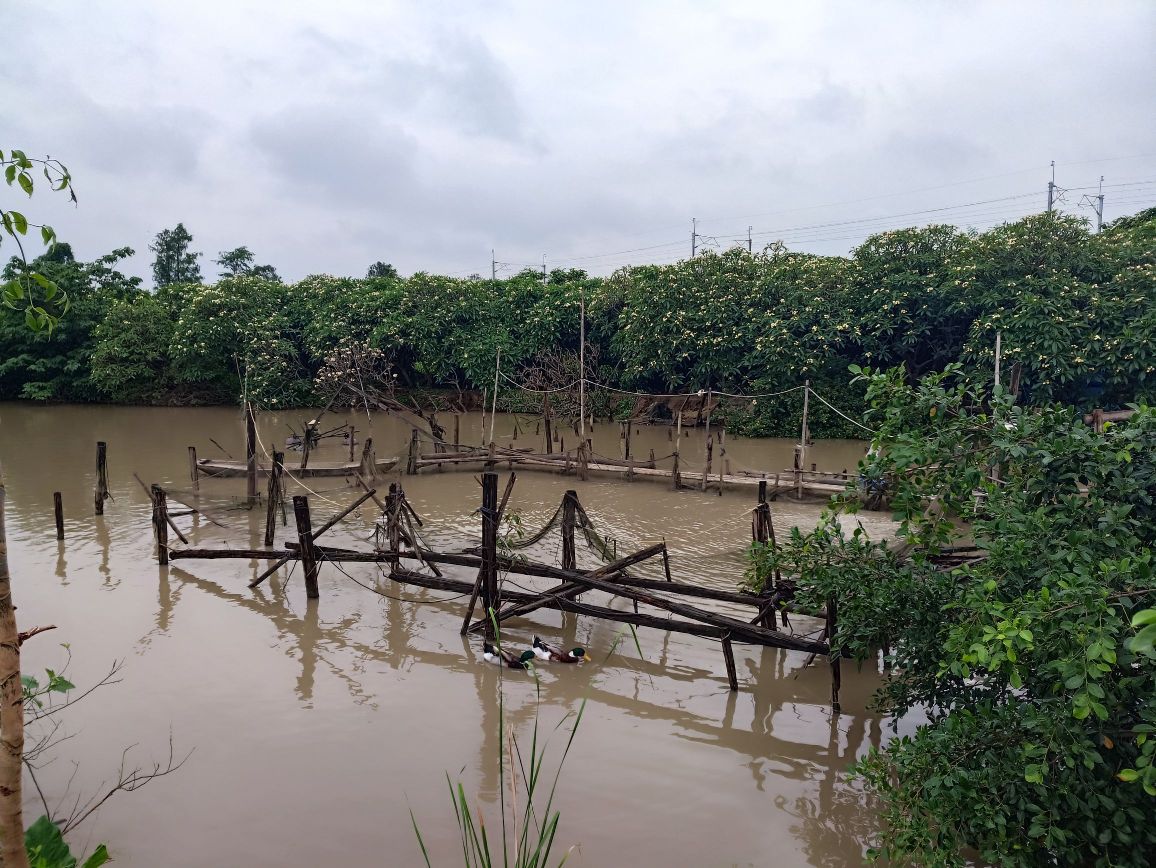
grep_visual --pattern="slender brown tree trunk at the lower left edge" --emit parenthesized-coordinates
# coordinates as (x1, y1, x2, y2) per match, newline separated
(0, 468, 28, 868)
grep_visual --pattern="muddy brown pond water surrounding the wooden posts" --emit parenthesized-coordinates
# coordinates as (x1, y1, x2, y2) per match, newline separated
(0, 403, 890, 867)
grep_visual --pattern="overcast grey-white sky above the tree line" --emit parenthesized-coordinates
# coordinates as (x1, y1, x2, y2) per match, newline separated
(0, 0, 1156, 280)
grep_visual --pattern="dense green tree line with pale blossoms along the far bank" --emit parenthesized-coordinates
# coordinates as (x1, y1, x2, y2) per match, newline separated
(0, 209, 1156, 435)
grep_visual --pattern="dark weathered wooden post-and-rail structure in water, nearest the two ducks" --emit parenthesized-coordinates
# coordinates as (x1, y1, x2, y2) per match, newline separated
(158, 470, 840, 710)
